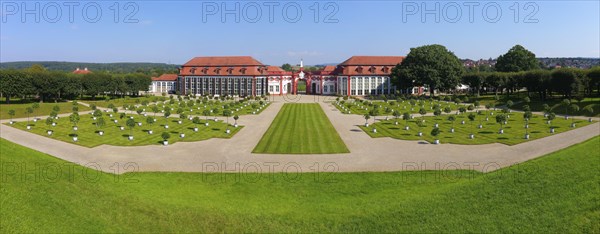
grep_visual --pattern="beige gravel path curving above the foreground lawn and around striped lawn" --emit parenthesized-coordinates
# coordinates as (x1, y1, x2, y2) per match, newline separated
(0, 96, 600, 173)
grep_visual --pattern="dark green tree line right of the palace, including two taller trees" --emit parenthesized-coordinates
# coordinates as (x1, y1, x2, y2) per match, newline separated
(391, 45, 600, 100)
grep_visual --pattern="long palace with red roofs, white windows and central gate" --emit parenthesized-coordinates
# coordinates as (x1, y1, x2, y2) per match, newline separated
(173, 56, 422, 96)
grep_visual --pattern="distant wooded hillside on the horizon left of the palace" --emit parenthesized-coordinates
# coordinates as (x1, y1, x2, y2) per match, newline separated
(0, 61, 179, 73)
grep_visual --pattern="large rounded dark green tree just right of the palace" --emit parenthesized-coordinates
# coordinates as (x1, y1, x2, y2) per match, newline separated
(391, 45, 464, 96)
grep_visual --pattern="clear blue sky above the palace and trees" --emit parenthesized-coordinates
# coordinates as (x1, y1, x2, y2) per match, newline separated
(0, 0, 600, 65)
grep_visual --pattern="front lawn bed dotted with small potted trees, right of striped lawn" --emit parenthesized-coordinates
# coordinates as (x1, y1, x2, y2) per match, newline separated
(360, 111, 591, 145)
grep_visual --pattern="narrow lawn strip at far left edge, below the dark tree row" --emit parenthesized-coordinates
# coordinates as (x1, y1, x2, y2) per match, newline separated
(0, 102, 90, 119)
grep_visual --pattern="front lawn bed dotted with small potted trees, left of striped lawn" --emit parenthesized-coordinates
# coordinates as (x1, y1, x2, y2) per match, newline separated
(7, 113, 242, 147)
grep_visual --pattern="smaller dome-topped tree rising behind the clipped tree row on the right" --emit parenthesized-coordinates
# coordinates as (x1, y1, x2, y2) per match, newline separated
(495, 45, 540, 72)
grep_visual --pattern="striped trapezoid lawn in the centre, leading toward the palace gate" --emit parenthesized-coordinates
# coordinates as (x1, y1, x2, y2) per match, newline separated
(252, 103, 350, 154)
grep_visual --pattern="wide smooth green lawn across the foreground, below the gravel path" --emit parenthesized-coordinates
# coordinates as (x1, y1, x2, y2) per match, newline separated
(0, 137, 600, 233)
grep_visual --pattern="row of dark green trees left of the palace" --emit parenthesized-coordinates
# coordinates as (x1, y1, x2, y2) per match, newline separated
(0, 66, 152, 103)
